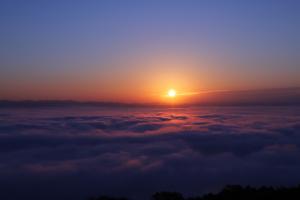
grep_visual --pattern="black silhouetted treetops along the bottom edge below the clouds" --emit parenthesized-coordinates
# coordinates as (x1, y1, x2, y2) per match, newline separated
(89, 185, 300, 200)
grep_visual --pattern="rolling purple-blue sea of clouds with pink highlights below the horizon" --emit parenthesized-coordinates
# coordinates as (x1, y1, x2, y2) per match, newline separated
(0, 107, 300, 200)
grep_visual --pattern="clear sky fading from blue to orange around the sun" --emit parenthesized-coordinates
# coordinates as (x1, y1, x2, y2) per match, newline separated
(0, 0, 300, 103)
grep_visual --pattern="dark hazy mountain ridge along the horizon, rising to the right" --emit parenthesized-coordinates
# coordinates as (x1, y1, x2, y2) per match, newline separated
(0, 87, 300, 107)
